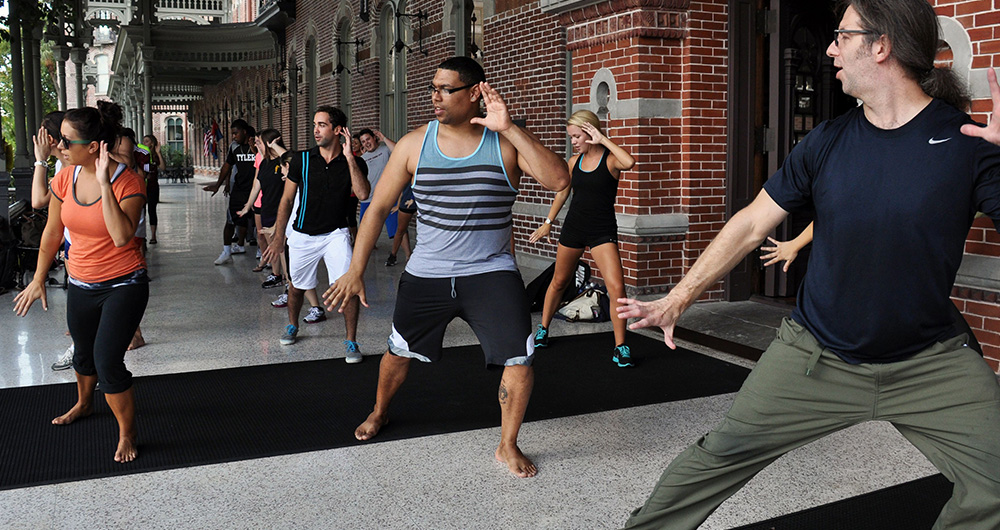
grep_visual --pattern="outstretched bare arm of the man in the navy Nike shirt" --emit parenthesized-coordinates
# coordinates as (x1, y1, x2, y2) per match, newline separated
(618, 191, 788, 349)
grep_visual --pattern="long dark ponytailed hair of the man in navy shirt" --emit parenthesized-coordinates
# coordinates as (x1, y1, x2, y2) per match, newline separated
(839, 0, 972, 111)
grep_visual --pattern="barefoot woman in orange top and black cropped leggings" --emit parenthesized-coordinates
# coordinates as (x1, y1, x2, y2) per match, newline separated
(14, 101, 149, 462)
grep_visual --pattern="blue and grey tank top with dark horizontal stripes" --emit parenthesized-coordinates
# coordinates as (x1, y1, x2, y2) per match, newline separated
(406, 121, 517, 278)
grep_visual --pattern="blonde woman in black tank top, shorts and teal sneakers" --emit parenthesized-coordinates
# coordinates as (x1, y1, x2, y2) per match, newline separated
(529, 110, 635, 368)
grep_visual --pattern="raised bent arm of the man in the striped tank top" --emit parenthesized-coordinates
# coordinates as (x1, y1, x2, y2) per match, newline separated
(471, 82, 569, 191)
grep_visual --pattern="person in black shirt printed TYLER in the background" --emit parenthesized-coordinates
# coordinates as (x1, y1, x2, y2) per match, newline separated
(202, 119, 257, 265)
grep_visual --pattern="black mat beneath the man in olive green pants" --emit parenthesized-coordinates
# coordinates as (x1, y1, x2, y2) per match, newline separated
(736, 475, 952, 530)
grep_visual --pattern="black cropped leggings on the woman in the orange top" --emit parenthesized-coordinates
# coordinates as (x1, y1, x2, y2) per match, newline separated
(66, 283, 149, 394)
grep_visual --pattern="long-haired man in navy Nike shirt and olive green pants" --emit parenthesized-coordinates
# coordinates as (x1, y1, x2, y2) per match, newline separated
(618, 0, 1000, 530)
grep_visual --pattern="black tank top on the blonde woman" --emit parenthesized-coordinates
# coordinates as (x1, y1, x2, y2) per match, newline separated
(566, 149, 618, 233)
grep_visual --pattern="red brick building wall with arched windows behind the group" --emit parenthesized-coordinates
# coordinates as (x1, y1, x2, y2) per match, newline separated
(176, 0, 1000, 370)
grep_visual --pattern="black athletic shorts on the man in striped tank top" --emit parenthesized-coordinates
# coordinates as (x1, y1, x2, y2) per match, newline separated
(388, 271, 535, 367)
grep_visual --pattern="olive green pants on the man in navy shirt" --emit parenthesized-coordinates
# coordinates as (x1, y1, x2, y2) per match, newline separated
(626, 318, 1000, 530)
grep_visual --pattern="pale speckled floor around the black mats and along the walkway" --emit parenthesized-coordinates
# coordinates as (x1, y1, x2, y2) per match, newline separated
(0, 184, 935, 530)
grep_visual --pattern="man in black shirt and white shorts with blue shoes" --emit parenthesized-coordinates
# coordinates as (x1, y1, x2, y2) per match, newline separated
(264, 106, 370, 363)
